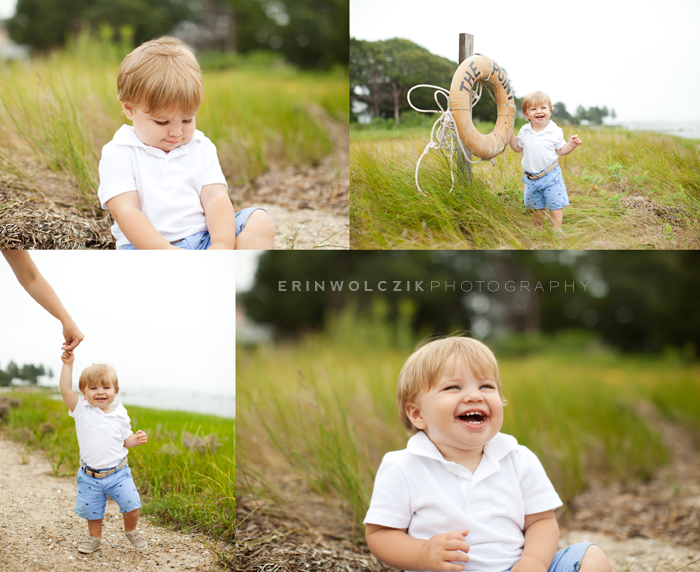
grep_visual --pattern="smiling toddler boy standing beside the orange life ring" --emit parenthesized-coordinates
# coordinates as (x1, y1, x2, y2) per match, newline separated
(509, 91, 582, 232)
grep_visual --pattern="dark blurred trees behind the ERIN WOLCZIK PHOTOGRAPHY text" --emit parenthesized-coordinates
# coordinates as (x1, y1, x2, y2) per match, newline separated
(241, 251, 700, 356)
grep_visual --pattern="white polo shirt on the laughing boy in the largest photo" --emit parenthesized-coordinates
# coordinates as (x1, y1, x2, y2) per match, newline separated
(364, 431, 562, 572)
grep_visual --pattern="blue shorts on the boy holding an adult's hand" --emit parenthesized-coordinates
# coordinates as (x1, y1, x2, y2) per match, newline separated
(75, 465, 141, 520)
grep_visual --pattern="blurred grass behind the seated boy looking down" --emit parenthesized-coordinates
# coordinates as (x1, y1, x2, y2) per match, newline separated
(0, 29, 349, 206)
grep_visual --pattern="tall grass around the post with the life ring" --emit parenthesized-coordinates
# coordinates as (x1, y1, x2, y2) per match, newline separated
(350, 116, 700, 250)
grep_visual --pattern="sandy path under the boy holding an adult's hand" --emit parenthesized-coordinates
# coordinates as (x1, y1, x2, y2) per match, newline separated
(0, 438, 224, 572)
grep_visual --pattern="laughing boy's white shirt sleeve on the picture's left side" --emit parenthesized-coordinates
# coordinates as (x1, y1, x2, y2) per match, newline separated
(364, 455, 412, 530)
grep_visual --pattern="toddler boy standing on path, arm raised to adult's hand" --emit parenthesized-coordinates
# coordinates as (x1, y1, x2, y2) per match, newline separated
(59, 351, 148, 554)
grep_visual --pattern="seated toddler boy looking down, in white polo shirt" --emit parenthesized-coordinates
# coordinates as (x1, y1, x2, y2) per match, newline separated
(98, 37, 274, 250)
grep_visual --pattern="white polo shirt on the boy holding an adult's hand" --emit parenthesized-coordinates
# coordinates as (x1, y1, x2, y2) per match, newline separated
(70, 395, 133, 469)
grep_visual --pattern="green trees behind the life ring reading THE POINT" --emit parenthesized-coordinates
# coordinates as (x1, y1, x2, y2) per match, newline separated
(350, 38, 615, 125)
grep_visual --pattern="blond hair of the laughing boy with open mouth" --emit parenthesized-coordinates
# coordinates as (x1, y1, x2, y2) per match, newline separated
(396, 336, 503, 433)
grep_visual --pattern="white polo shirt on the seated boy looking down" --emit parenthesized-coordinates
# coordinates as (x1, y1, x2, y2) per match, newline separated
(97, 125, 226, 248)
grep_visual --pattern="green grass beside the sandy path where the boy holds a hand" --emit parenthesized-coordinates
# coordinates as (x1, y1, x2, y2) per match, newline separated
(2, 391, 236, 542)
